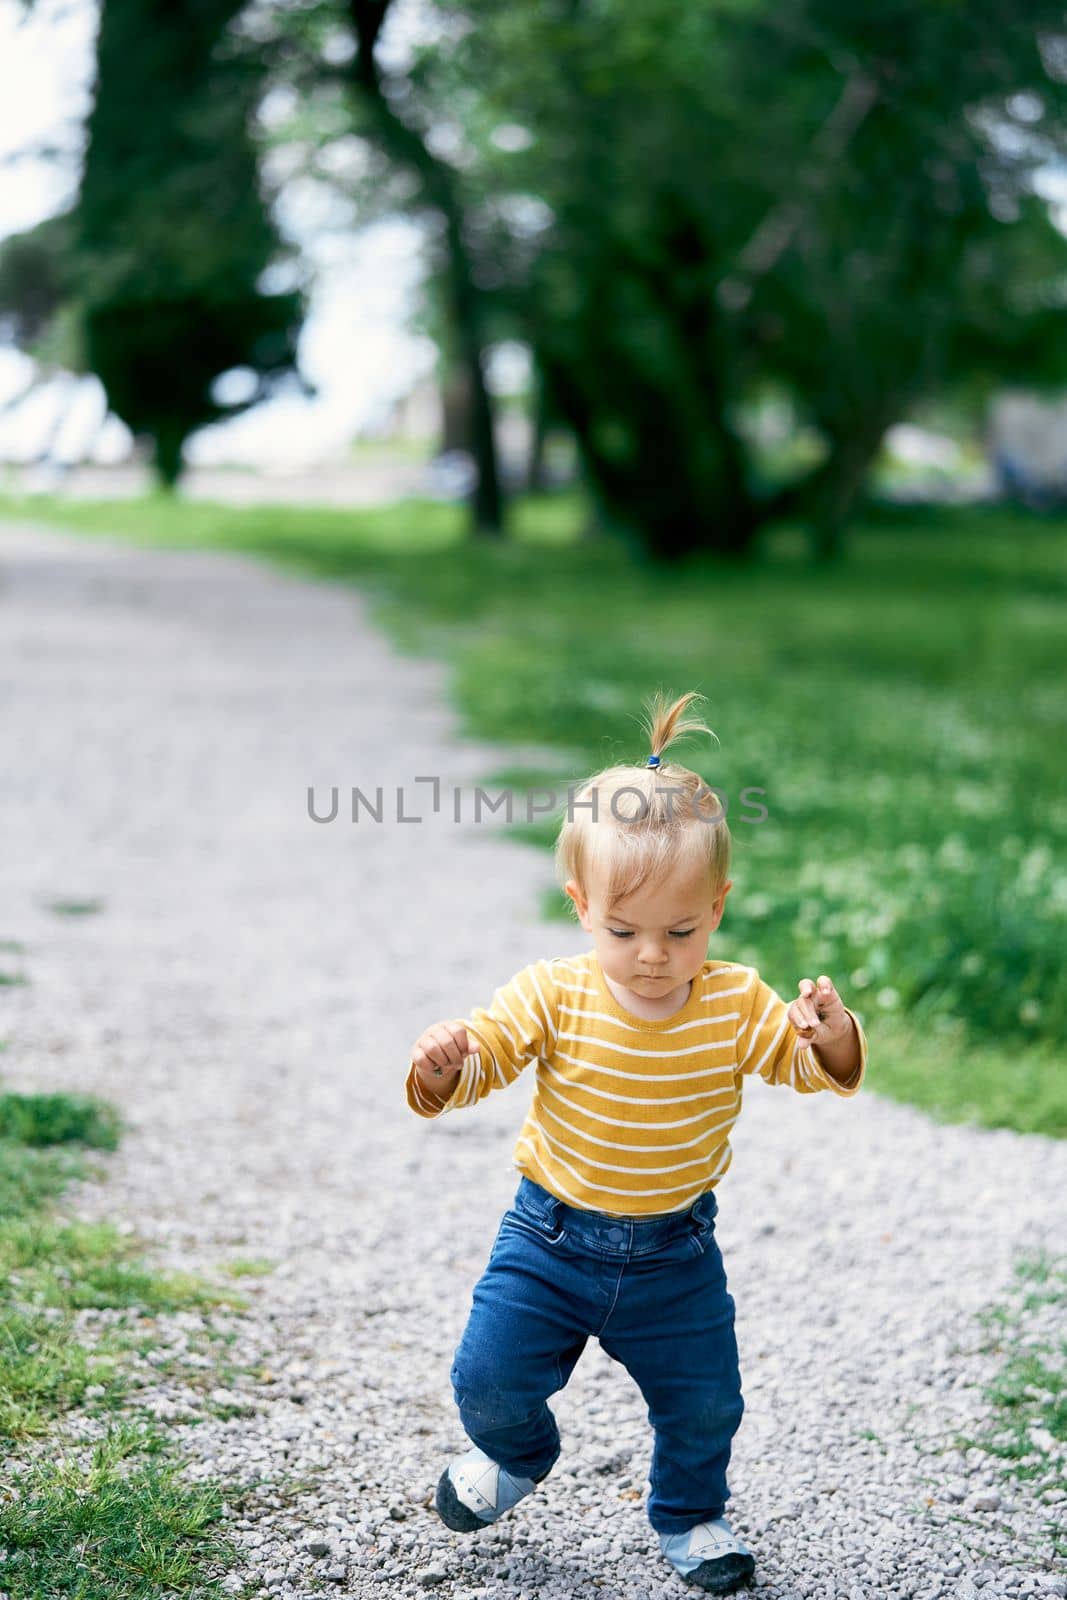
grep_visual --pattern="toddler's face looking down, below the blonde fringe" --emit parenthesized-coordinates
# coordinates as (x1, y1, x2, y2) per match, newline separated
(566, 872, 733, 1000)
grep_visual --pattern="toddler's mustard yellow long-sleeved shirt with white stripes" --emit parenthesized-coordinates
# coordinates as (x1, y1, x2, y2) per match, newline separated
(406, 950, 867, 1216)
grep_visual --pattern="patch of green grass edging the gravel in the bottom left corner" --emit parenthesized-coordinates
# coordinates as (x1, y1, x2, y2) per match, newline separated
(0, 1093, 246, 1600)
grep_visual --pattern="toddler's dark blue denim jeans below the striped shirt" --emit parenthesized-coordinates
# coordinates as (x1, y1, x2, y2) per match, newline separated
(451, 1178, 744, 1533)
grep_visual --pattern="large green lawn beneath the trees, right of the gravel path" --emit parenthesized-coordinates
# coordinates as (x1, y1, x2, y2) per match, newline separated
(0, 496, 1067, 1138)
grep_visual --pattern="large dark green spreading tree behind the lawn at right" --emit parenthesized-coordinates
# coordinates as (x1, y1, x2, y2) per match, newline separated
(437, 0, 1067, 558)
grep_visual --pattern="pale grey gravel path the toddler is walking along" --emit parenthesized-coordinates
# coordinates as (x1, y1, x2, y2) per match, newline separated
(0, 525, 1067, 1600)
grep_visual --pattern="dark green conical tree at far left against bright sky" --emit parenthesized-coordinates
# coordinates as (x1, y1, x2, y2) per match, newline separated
(0, 0, 302, 483)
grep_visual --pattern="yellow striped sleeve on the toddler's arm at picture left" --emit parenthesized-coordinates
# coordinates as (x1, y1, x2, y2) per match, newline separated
(406, 962, 558, 1117)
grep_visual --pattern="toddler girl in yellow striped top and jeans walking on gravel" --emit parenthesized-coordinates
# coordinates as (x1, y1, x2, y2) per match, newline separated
(406, 694, 867, 1594)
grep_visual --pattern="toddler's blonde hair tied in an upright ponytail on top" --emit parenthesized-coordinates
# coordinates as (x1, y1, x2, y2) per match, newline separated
(555, 690, 731, 907)
